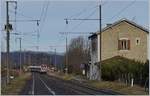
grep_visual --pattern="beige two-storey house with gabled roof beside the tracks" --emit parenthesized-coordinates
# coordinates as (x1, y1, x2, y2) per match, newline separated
(89, 19, 149, 79)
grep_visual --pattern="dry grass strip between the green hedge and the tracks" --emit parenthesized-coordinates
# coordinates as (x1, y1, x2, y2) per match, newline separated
(88, 81, 148, 95)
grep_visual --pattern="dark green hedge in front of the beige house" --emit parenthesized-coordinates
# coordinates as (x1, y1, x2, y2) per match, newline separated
(102, 56, 149, 85)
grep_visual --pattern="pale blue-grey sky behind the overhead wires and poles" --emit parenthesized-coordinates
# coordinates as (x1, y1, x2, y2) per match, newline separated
(1, 0, 149, 52)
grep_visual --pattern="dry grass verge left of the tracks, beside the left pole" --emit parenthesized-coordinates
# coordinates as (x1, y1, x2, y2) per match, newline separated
(1, 73, 31, 95)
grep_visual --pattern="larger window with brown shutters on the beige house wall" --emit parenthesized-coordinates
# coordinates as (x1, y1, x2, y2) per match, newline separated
(118, 39, 130, 50)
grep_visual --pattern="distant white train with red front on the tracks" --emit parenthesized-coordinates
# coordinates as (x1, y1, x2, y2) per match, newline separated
(28, 64, 48, 73)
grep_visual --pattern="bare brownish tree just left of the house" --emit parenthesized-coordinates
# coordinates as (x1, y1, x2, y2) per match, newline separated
(63, 36, 90, 74)
